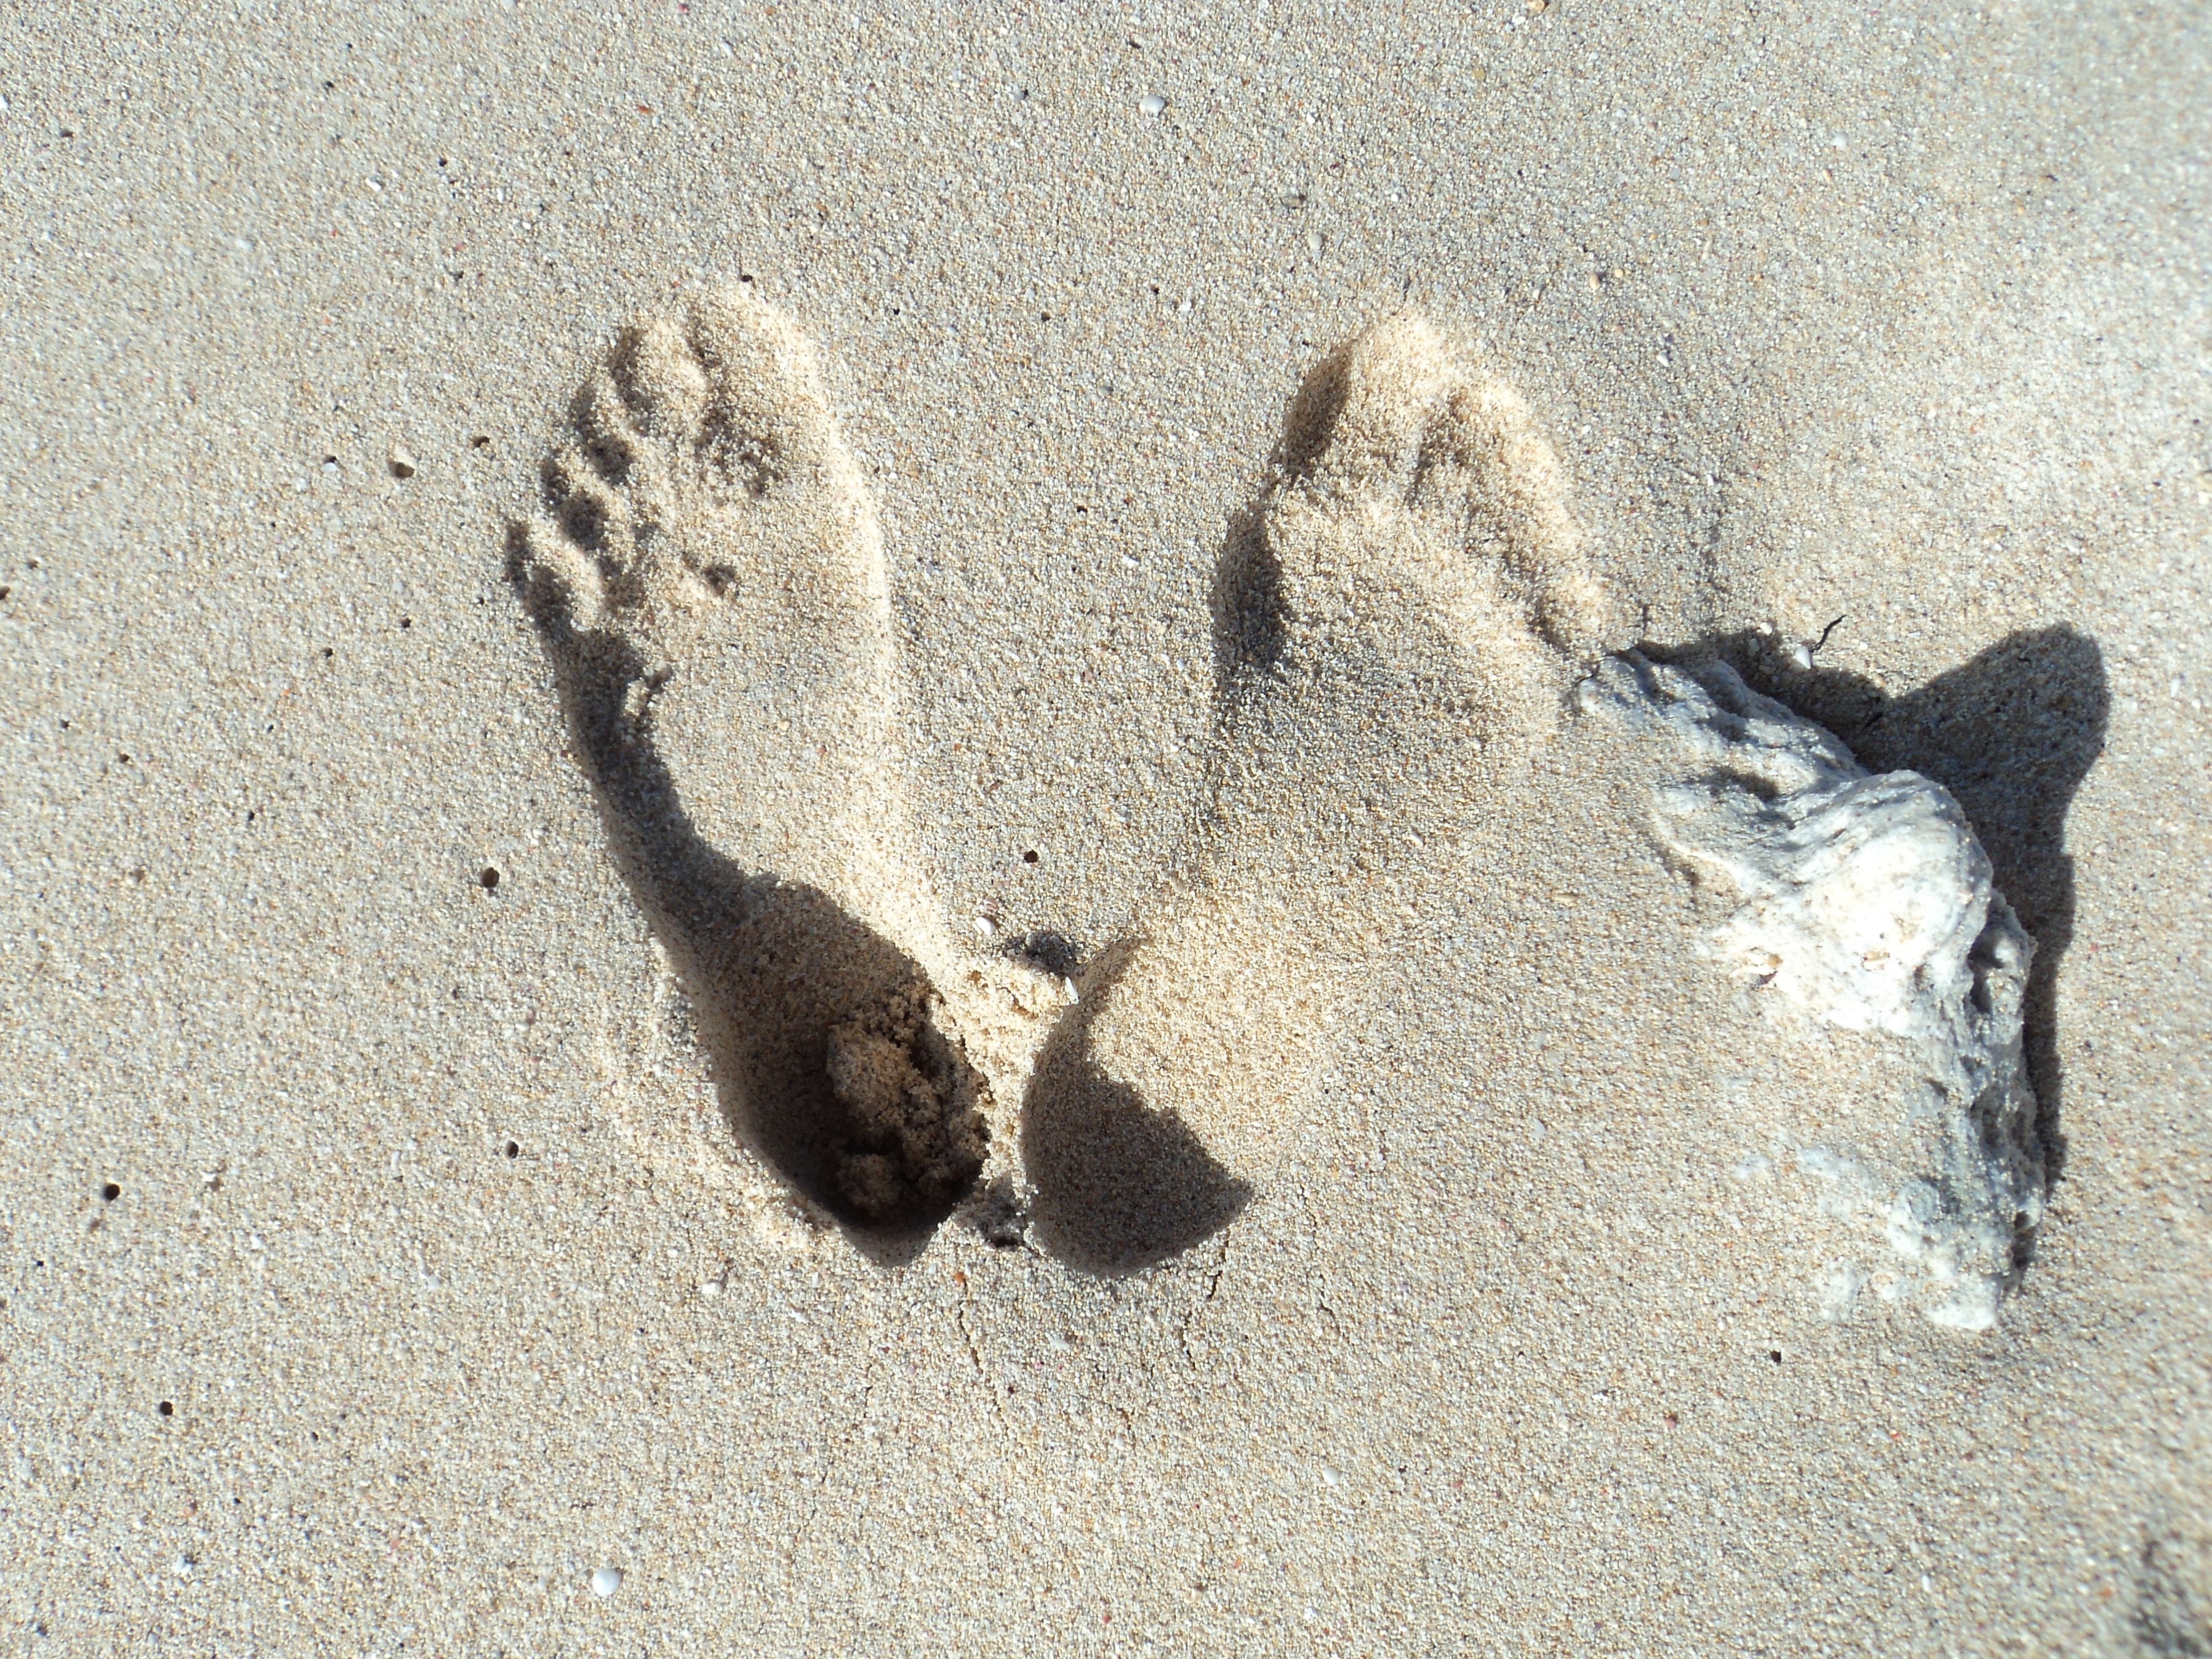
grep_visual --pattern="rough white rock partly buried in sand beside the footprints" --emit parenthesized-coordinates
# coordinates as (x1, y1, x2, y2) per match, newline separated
(1582, 653, 2044, 1329)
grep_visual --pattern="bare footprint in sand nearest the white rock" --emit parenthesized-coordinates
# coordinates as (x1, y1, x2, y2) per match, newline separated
(1022, 316, 1606, 1272)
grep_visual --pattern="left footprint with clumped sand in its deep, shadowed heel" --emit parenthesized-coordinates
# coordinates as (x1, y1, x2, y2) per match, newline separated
(509, 290, 1060, 1256)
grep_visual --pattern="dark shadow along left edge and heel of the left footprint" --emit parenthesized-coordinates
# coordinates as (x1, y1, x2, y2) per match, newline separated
(507, 526, 982, 1265)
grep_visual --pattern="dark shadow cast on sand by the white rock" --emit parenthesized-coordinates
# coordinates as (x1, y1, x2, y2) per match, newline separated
(1655, 626, 2110, 1179)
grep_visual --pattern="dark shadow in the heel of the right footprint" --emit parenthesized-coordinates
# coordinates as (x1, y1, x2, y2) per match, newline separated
(1022, 947, 1252, 1274)
